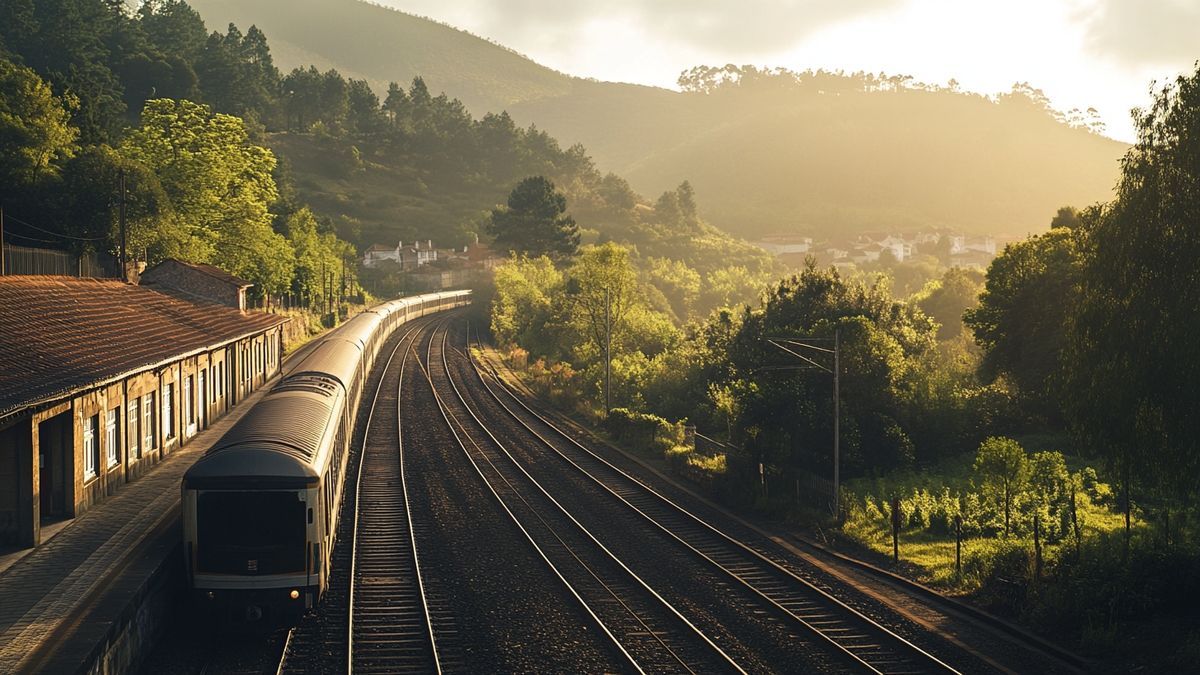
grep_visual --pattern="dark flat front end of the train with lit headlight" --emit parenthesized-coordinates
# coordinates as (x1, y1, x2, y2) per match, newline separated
(182, 441, 323, 625)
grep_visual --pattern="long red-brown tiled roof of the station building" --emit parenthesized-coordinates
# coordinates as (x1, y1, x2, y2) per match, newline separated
(0, 276, 287, 418)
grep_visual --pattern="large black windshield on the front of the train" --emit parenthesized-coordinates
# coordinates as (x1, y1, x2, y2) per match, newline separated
(196, 491, 307, 575)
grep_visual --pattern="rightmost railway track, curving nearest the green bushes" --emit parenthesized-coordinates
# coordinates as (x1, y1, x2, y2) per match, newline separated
(451, 319, 956, 674)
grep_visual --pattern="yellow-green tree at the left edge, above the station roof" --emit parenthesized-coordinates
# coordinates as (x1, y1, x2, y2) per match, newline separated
(0, 59, 79, 185)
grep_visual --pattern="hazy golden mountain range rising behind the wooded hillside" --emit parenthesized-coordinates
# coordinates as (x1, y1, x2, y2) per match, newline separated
(192, 0, 1127, 237)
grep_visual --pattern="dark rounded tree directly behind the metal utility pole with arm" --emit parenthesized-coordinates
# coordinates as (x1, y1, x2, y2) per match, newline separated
(724, 261, 935, 474)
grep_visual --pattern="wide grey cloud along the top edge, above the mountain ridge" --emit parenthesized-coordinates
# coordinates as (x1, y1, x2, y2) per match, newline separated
(389, 0, 906, 58)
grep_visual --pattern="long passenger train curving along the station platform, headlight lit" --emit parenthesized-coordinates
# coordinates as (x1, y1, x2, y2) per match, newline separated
(181, 291, 470, 626)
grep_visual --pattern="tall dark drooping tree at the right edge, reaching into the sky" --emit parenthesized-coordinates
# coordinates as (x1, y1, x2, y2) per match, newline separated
(1070, 64, 1200, 532)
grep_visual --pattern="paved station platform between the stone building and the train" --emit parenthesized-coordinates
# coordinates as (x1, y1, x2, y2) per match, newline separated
(0, 344, 311, 673)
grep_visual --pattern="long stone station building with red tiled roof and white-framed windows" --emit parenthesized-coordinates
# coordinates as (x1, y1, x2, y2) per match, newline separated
(0, 261, 287, 546)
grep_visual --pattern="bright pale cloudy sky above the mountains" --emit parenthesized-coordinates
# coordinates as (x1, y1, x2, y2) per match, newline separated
(377, 0, 1200, 142)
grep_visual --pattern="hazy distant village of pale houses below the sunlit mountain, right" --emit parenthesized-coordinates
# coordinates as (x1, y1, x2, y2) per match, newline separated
(755, 229, 996, 269)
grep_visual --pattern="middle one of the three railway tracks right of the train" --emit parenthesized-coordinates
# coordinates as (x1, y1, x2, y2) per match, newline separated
(426, 322, 744, 673)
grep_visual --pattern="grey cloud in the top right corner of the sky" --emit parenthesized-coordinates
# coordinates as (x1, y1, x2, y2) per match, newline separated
(1080, 0, 1200, 66)
